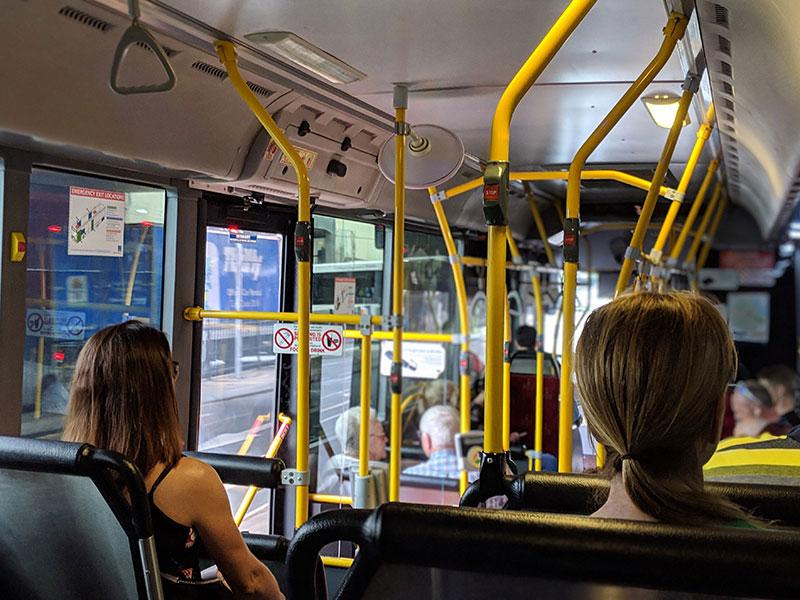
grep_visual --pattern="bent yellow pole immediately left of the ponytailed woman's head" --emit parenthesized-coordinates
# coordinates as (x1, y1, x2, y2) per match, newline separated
(558, 13, 689, 473)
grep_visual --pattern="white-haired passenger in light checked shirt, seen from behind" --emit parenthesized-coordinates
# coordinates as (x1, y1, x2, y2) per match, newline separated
(403, 405, 460, 479)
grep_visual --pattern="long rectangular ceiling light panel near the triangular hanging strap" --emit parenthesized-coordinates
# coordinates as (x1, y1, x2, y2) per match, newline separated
(244, 31, 367, 83)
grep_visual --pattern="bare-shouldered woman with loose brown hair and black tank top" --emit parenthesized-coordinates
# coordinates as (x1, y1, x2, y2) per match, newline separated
(64, 321, 283, 600)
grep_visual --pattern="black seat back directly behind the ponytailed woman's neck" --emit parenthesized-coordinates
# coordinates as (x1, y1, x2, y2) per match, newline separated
(521, 473, 800, 527)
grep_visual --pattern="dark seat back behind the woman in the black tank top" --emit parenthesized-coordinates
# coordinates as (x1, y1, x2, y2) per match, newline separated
(0, 436, 162, 600)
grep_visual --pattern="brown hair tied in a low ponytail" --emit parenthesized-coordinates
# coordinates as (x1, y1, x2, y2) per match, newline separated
(575, 292, 747, 524)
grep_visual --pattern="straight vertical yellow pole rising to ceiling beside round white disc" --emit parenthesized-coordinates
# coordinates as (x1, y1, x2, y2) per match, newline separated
(389, 85, 410, 502)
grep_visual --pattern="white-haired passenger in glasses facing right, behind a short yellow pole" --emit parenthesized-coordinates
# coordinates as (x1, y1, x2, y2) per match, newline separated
(317, 406, 389, 498)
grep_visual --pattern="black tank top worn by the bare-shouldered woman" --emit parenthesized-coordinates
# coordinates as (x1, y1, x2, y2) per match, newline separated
(148, 465, 205, 582)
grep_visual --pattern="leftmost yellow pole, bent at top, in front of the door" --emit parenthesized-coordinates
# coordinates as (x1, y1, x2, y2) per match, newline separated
(214, 40, 311, 527)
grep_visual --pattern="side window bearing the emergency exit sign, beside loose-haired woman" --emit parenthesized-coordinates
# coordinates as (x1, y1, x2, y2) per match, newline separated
(22, 169, 166, 437)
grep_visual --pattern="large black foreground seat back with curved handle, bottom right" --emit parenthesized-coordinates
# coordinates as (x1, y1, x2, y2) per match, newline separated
(287, 503, 800, 600)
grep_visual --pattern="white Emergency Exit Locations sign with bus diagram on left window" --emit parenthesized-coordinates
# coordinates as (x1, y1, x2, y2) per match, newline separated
(67, 186, 125, 256)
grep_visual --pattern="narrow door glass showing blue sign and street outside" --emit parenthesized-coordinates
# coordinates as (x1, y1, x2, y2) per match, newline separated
(198, 226, 283, 456)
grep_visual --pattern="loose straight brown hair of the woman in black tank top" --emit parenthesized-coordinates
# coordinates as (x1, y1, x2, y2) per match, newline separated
(64, 321, 181, 476)
